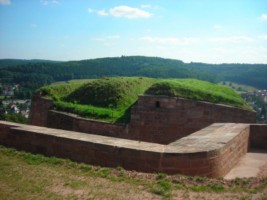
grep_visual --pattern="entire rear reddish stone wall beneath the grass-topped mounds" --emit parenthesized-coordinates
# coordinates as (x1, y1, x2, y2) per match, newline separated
(30, 95, 256, 144)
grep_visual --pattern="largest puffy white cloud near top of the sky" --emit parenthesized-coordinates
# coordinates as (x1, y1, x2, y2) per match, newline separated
(109, 6, 152, 19)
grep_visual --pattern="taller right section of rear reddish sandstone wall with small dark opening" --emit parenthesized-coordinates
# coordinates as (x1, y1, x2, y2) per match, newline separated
(129, 96, 256, 144)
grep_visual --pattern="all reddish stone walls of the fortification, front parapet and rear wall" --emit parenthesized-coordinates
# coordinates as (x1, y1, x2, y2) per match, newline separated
(0, 95, 267, 177)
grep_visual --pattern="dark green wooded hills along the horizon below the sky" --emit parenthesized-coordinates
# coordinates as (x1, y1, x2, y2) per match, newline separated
(0, 56, 267, 97)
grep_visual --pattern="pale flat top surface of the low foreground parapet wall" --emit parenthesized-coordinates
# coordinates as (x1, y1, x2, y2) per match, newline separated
(0, 121, 249, 154)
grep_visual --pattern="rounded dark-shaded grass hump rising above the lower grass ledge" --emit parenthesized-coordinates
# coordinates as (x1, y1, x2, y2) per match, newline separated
(65, 77, 157, 109)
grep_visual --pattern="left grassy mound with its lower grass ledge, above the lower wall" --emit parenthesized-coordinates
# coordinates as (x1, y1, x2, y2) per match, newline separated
(40, 77, 156, 123)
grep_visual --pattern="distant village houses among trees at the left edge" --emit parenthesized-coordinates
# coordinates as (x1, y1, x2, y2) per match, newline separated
(0, 84, 31, 118)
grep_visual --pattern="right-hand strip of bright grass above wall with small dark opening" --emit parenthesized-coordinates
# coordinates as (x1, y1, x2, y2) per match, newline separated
(146, 79, 251, 110)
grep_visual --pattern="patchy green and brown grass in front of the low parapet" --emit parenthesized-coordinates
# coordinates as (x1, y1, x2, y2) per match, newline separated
(0, 145, 267, 199)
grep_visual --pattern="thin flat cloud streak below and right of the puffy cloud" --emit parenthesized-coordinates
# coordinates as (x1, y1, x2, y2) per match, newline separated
(140, 36, 199, 45)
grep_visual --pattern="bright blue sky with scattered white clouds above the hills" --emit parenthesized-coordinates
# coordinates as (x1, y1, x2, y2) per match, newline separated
(0, 0, 267, 63)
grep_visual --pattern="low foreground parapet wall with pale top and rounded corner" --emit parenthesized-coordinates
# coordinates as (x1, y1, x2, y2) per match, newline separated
(0, 121, 250, 177)
